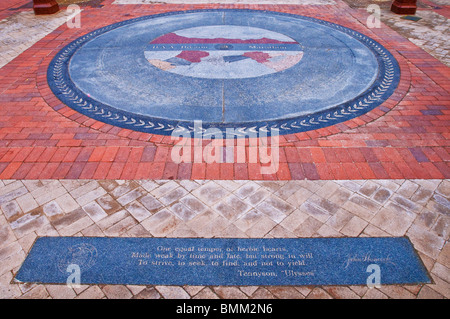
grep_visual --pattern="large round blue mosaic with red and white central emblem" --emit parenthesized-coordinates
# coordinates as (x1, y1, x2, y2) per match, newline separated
(47, 9, 400, 137)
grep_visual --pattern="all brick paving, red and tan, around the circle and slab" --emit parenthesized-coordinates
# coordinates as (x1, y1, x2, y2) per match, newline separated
(0, 0, 450, 299)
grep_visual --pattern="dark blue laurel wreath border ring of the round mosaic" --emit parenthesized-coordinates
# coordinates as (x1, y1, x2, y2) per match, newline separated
(47, 9, 400, 138)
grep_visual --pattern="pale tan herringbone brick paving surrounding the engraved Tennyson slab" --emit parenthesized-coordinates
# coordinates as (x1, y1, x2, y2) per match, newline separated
(0, 179, 450, 299)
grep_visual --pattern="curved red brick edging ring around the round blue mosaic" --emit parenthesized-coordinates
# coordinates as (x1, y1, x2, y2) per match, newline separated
(37, 5, 410, 145)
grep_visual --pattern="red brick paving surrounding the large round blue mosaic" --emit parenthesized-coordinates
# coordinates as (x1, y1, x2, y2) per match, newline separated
(0, 0, 450, 180)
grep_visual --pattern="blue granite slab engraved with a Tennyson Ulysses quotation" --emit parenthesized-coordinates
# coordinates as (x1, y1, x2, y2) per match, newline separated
(15, 237, 431, 286)
